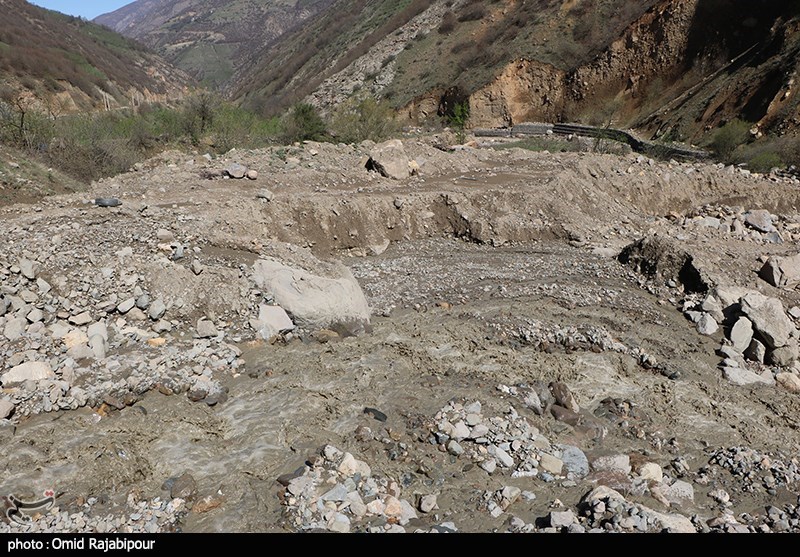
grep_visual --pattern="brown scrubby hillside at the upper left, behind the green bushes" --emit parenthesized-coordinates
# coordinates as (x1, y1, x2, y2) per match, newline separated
(0, 0, 191, 111)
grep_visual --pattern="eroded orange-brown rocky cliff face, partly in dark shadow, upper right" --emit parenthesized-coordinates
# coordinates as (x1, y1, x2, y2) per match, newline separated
(456, 0, 798, 137)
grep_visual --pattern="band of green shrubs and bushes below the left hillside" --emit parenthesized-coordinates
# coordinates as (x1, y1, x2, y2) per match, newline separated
(0, 89, 282, 182)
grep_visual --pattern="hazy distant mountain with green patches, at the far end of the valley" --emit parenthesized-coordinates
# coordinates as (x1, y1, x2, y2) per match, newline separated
(94, 0, 333, 87)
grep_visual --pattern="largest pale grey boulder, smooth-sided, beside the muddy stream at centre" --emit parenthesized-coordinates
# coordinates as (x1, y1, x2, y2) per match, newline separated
(253, 256, 370, 334)
